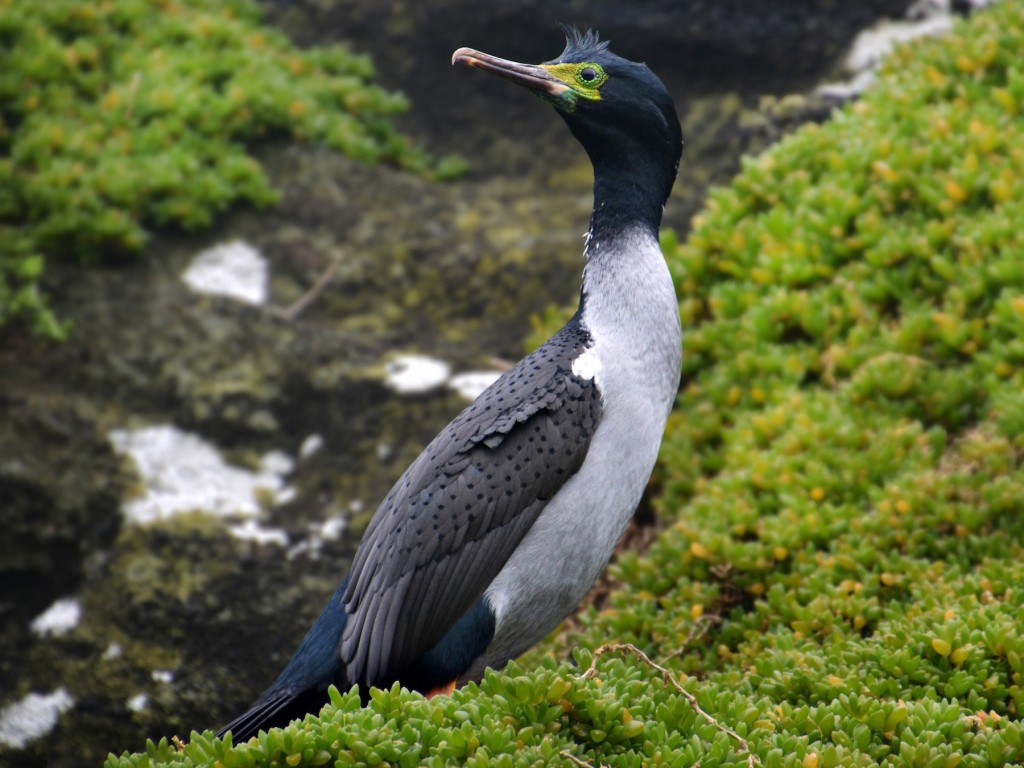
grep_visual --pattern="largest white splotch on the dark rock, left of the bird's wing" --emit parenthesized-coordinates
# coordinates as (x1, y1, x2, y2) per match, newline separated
(108, 425, 293, 524)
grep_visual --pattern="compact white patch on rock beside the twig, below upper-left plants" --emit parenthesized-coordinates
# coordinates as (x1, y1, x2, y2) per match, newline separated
(181, 240, 269, 304)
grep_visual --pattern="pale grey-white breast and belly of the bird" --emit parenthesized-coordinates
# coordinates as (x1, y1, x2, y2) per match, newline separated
(464, 224, 682, 680)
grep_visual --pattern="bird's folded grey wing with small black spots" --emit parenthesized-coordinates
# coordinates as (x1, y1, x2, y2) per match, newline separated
(339, 323, 601, 685)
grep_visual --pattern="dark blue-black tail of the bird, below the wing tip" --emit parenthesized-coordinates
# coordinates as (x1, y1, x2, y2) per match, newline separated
(217, 575, 349, 743)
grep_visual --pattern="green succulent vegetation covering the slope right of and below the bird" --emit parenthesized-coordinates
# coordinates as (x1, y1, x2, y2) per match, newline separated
(108, 1, 1024, 768)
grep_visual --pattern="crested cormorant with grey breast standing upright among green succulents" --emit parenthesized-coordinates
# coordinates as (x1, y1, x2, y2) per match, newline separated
(218, 27, 683, 742)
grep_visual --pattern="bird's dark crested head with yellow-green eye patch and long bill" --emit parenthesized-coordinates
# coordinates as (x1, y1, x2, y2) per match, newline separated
(452, 28, 683, 210)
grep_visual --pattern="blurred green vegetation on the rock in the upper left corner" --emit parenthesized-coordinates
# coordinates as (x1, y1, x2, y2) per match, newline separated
(0, 0, 459, 336)
